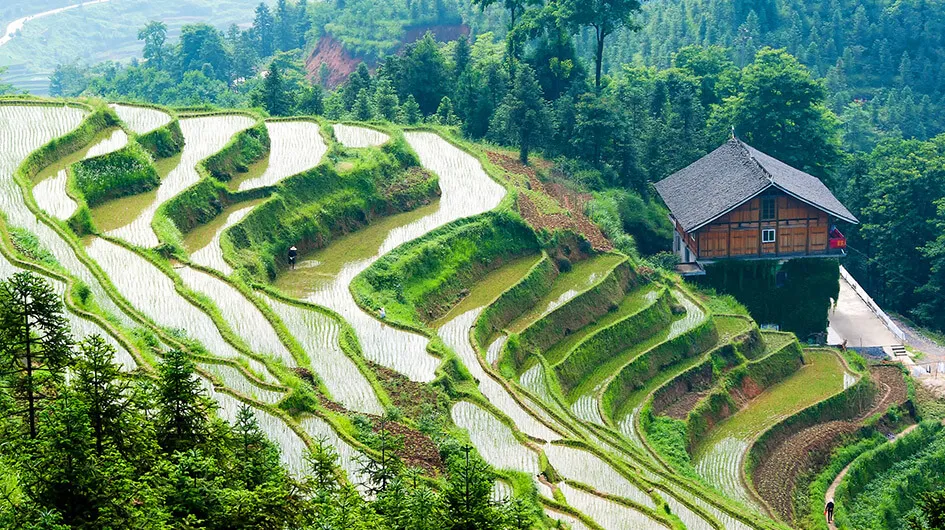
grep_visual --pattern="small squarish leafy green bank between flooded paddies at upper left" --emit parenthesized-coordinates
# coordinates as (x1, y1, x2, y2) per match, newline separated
(71, 142, 161, 206)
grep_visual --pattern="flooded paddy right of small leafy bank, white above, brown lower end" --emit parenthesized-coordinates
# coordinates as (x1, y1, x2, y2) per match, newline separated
(102, 116, 254, 248)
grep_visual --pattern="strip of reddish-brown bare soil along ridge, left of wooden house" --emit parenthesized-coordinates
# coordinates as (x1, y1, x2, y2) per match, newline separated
(487, 151, 614, 252)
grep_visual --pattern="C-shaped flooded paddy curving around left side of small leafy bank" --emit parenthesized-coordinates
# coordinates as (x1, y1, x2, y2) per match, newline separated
(33, 129, 128, 220)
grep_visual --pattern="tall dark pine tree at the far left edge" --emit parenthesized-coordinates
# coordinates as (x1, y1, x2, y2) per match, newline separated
(0, 272, 73, 438)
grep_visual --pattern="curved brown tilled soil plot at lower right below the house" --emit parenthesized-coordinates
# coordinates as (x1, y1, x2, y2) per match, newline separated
(752, 366, 908, 521)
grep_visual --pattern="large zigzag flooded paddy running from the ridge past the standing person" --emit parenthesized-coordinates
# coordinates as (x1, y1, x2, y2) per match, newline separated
(277, 132, 506, 382)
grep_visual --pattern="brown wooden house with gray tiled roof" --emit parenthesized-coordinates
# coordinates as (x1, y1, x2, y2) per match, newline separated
(656, 137, 858, 275)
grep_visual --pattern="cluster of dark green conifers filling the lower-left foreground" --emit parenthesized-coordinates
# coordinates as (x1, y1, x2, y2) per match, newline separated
(0, 272, 537, 530)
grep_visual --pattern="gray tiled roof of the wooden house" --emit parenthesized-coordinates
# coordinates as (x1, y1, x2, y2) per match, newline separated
(656, 138, 858, 231)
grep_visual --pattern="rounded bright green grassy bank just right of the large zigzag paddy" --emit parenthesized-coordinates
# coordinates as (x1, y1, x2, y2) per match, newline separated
(351, 212, 539, 326)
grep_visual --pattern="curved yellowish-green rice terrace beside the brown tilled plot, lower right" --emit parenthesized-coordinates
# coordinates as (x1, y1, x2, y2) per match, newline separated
(693, 351, 846, 506)
